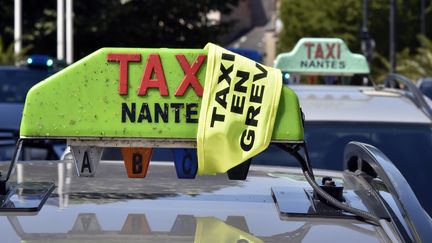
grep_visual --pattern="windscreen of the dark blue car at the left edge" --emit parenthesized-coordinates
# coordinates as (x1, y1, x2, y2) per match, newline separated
(0, 68, 50, 103)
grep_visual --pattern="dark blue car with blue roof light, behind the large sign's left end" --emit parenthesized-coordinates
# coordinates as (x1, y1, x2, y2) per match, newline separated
(0, 55, 65, 161)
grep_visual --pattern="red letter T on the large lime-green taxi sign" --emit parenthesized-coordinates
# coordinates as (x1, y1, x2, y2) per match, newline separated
(107, 53, 141, 95)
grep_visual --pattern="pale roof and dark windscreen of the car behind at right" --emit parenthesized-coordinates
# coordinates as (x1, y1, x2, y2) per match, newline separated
(290, 85, 432, 214)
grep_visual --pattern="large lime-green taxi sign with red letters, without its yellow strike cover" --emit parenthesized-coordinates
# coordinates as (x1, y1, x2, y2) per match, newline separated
(20, 48, 303, 141)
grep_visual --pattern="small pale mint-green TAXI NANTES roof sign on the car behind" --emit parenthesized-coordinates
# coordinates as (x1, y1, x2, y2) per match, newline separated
(275, 38, 370, 75)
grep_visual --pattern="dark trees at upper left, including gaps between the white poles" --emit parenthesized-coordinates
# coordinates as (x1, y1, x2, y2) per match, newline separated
(0, 0, 239, 59)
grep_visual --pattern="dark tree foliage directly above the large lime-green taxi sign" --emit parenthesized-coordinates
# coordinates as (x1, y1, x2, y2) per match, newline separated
(75, 0, 238, 56)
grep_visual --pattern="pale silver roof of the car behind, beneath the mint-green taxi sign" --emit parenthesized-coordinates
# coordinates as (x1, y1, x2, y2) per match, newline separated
(290, 85, 431, 124)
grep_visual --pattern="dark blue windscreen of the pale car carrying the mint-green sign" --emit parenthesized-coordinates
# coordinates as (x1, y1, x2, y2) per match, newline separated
(252, 122, 432, 215)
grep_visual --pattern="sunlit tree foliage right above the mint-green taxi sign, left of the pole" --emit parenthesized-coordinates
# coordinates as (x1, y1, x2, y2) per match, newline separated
(278, 0, 361, 52)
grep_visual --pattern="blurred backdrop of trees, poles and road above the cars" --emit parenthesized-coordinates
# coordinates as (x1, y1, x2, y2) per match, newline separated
(0, 0, 432, 82)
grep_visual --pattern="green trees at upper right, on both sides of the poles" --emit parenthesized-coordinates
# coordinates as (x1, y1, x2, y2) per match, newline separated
(278, 0, 432, 81)
